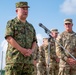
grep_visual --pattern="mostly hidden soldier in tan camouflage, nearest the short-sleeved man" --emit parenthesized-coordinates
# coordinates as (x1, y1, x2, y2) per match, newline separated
(37, 38, 48, 75)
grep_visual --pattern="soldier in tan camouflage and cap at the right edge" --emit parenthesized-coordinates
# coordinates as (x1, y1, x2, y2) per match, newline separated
(56, 19, 76, 75)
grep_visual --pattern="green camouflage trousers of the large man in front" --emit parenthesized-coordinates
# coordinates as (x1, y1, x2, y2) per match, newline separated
(5, 63, 34, 75)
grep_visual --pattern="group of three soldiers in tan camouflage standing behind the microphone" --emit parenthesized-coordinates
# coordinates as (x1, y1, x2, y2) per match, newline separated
(35, 19, 76, 75)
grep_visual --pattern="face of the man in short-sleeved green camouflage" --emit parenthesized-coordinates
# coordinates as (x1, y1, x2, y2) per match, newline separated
(16, 7, 28, 19)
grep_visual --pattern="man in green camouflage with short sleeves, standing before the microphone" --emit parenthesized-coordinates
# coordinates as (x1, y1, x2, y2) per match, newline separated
(5, 2, 37, 75)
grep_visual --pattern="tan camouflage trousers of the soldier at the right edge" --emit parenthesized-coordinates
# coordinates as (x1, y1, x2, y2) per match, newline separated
(58, 60, 76, 75)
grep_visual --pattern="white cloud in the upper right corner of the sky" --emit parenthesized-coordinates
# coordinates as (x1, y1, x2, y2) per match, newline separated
(60, 0, 76, 15)
